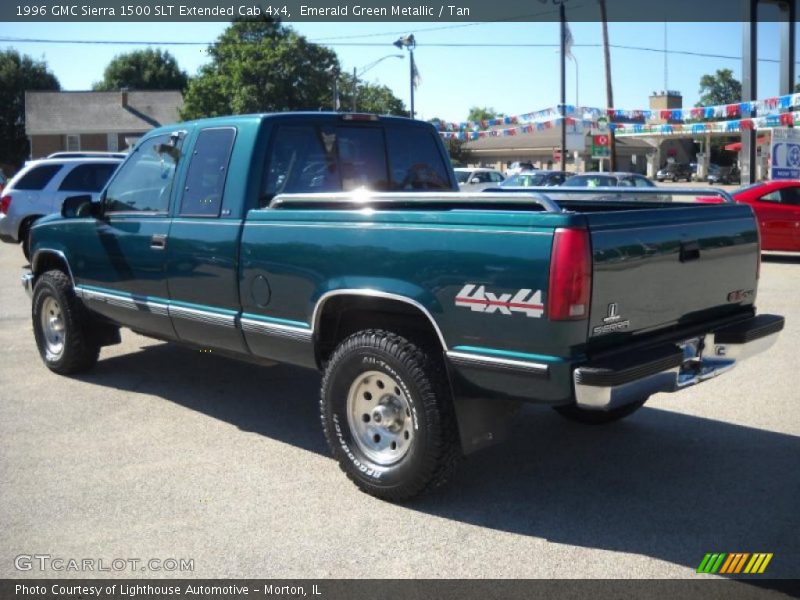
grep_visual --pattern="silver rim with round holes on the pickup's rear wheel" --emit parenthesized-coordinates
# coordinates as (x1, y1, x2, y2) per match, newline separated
(347, 371, 414, 465)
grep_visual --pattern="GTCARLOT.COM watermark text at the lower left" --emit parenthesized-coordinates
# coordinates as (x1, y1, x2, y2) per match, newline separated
(14, 554, 194, 573)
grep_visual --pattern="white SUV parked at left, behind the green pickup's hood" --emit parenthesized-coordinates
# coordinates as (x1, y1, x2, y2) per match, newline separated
(0, 158, 122, 258)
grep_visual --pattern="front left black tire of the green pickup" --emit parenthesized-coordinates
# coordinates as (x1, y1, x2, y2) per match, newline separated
(31, 271, 100, 375)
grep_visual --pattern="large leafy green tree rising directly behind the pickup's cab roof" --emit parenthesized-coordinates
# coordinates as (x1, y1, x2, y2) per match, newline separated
(181, 18, 339, 119)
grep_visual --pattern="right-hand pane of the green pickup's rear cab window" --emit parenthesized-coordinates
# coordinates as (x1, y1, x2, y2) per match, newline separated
(386, 127, 450, 191)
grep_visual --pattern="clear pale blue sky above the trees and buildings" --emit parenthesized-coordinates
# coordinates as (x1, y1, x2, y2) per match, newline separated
(0, 22, 796, 121)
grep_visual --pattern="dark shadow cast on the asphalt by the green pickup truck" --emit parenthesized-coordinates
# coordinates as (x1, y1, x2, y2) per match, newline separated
(76, 344, 800, 577)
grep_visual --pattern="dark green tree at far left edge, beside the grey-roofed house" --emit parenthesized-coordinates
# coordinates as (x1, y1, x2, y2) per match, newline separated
(0, 50, 61, 169)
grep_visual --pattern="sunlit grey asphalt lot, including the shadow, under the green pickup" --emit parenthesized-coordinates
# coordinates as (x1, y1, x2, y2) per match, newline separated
(0, 244, 800, 578)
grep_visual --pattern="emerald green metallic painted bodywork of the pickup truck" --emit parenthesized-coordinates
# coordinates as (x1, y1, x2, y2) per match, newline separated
(23, 113, 756, 404)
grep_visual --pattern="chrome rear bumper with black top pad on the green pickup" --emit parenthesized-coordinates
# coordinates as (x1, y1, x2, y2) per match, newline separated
(573, 315, 784, 410)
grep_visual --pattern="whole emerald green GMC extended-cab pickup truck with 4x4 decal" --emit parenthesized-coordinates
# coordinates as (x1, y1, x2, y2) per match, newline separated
(23, 113, 783, 501)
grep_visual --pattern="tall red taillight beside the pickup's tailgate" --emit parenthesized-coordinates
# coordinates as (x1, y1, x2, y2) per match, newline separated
(547, 229, 592, 321)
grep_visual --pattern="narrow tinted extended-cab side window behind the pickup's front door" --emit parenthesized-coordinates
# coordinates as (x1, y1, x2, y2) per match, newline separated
(180, 127, 236, 217)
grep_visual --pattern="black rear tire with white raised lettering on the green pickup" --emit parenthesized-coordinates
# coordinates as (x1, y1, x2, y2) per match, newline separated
(320, 330, 461, 502)
